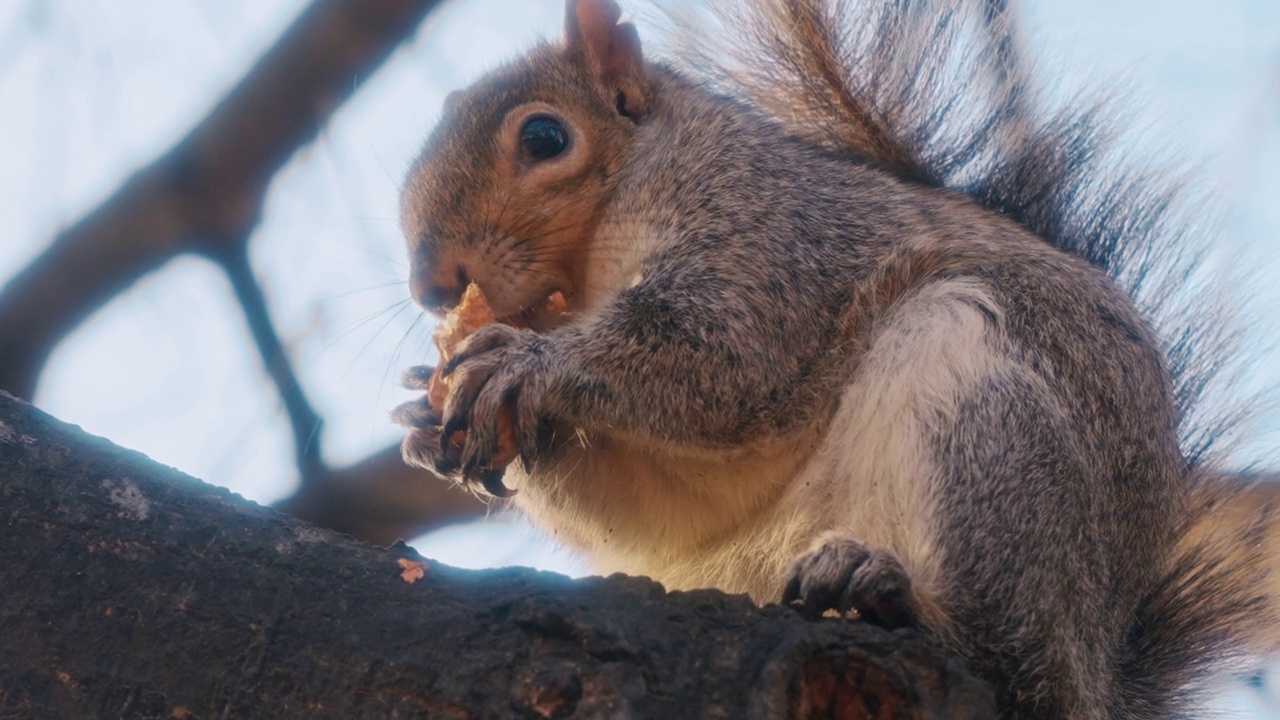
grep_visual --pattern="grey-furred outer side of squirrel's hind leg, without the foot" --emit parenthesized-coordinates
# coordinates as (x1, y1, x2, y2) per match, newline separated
(934, 365, 1121, 717)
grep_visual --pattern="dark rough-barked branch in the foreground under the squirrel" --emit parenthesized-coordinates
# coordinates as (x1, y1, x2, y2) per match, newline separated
(0, 393, 991, 719)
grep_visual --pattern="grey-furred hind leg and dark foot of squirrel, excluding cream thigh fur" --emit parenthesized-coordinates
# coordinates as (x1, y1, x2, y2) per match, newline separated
(782, 366, 1111, 719)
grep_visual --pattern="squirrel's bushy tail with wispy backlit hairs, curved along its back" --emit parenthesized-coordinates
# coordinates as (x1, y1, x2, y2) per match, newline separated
(659, 0, 1276, 714)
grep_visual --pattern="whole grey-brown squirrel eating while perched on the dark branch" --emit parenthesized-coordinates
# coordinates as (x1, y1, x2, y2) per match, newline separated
(397, 0, 1272, 719)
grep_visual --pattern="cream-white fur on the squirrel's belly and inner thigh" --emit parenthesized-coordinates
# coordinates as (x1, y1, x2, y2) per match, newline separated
(511, 278, 1010, 602)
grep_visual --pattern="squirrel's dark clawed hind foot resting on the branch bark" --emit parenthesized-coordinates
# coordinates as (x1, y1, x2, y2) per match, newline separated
(782, 536, 919, 629)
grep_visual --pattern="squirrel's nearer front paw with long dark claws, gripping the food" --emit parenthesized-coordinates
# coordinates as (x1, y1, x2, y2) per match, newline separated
(436, 324, 550, 496)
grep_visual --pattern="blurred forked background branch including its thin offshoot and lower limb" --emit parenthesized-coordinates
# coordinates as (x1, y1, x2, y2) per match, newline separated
(0, 0, 484, 542)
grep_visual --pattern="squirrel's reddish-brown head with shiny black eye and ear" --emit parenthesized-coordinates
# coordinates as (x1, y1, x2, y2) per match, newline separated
(401, 0, 654, 325)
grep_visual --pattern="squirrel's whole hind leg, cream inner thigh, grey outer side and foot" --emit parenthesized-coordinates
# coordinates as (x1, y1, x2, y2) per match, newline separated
(778, 274, 1121, 717)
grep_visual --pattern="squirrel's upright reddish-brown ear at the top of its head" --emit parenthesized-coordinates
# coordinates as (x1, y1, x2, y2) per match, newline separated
(564, 0, 648, 119)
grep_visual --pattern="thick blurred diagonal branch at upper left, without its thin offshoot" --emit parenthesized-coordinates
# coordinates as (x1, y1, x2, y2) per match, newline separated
(0, 0, 439, 397)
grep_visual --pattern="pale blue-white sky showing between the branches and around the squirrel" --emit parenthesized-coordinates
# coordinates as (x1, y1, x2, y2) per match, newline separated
(0, 0, 1280, 707)
